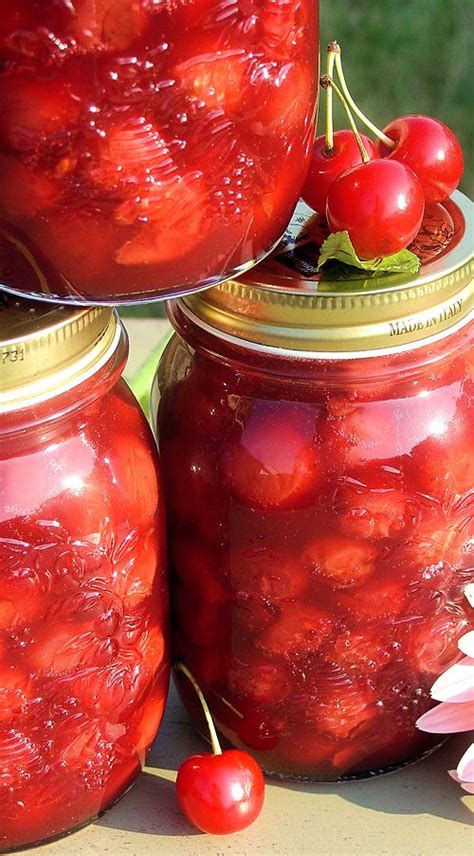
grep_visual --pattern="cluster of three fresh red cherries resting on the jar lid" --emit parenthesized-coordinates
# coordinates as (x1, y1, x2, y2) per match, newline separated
(302, 115, 463, 259)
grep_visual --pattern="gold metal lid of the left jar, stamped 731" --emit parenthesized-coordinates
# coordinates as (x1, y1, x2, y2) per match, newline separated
(0, 293, 124, 413)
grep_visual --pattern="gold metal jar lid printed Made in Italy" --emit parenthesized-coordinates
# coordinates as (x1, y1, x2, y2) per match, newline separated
(178, 192, 474, 358)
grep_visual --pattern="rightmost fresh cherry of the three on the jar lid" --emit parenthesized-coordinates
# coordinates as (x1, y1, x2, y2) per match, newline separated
(378, 116, 464, 205)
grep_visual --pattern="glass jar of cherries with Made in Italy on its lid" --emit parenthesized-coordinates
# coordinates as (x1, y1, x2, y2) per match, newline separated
(154, 194, 474, 781)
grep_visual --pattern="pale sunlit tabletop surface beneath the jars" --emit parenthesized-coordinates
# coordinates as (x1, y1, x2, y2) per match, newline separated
(13, 319, 474, 856)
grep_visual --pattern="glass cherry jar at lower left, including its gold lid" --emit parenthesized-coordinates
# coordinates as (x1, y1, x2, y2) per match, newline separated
(0, 297, 169, 852)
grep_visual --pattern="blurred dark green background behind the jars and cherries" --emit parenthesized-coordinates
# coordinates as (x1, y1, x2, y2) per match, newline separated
(122, 0, 474, 317)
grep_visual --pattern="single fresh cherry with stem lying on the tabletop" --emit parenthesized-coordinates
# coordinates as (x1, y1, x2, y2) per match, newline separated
(176, 663, 265, 835)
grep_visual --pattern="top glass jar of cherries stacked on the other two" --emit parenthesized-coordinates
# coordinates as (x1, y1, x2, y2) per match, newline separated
(0, 0, 319, 303)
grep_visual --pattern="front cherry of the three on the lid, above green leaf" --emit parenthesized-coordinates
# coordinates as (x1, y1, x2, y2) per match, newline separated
(326, 159, 425, 259)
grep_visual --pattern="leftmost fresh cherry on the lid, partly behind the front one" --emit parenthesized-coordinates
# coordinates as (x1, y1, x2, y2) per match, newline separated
(301, 128, 380, 214)
